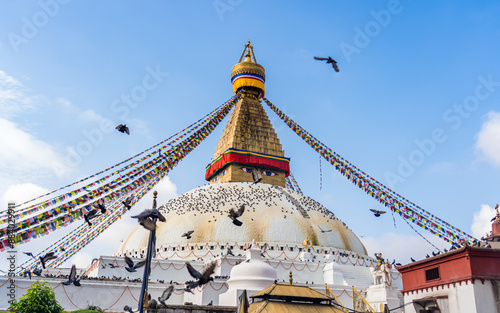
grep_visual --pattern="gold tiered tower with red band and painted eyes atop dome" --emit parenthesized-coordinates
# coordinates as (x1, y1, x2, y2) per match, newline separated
(205, 41, 290, 187)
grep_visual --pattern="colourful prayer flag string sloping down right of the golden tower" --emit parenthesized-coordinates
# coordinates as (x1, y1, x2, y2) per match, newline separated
(262, 98, 475, 243)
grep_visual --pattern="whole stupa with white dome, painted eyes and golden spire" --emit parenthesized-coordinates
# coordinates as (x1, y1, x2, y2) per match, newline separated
(0, 42, 402, 312)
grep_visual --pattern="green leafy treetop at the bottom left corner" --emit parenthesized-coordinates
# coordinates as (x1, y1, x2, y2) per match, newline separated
(9, 281, 63, 313)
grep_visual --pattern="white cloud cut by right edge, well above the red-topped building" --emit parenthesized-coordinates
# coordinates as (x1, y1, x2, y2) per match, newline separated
(476, 111, 500, 166)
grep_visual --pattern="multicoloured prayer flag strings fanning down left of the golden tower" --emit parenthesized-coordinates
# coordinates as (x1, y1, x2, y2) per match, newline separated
(0, 93, 241, 262)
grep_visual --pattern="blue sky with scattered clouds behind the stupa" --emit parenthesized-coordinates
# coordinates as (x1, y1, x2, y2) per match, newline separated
(0, 0, 500, 268)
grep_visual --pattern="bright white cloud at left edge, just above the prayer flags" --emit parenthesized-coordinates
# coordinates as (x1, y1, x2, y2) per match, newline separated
(0, 118, 63, 170)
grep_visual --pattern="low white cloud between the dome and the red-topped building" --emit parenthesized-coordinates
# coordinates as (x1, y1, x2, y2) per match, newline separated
(361, 232, 450, 264)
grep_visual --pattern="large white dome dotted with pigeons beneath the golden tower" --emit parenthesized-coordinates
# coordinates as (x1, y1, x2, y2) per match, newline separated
(119, 183, 366, 255)
